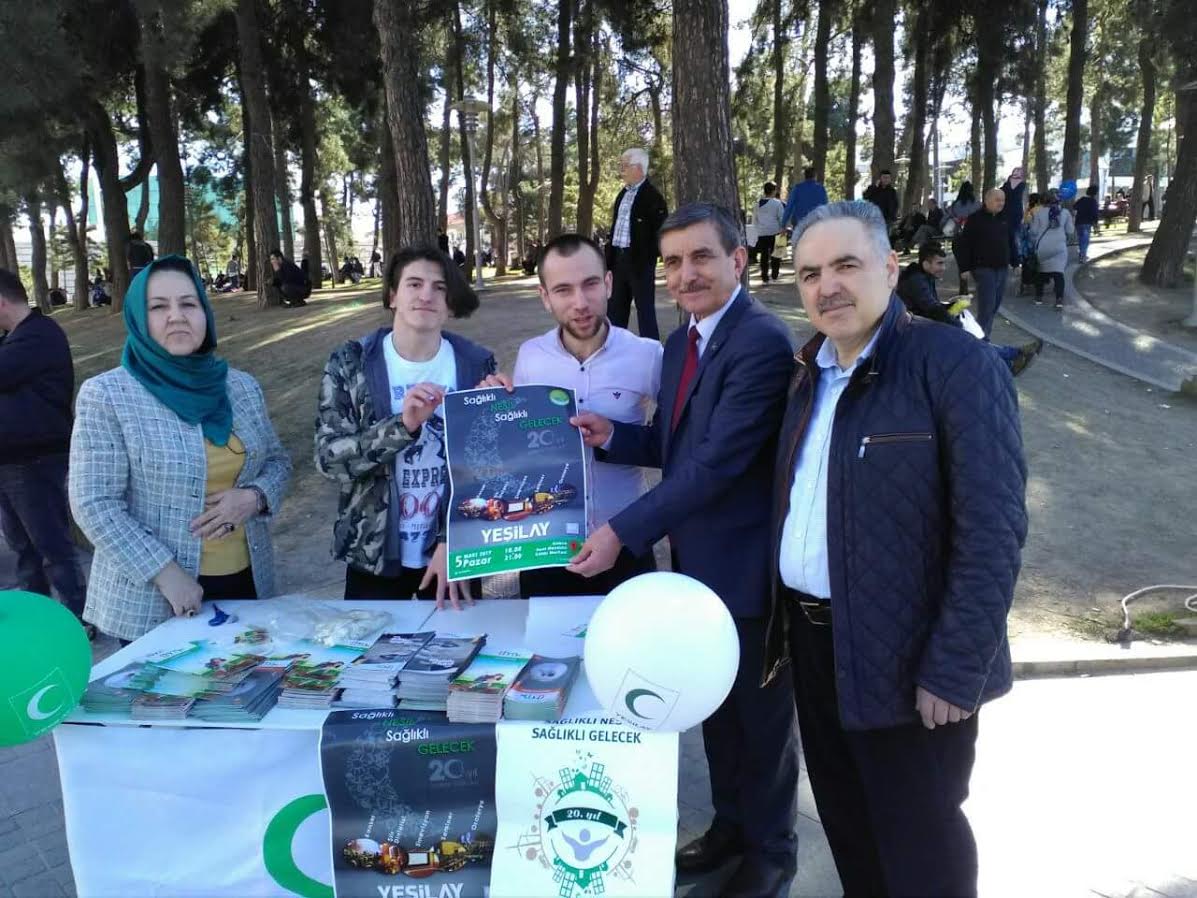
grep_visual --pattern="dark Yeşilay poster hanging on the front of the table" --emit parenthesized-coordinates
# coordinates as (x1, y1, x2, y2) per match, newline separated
(320, 710, 496, 898)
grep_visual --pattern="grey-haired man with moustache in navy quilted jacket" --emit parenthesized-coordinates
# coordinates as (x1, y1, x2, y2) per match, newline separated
(764, 202, 1027, 896)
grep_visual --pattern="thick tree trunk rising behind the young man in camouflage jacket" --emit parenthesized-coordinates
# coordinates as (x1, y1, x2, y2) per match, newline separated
(373, 0, 437, 245)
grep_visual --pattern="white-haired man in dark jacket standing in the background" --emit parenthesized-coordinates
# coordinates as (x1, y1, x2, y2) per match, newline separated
(607, 148, 669, 340)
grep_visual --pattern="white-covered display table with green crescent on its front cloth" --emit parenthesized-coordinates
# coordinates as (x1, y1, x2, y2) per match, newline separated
(55, 596, 646, 898)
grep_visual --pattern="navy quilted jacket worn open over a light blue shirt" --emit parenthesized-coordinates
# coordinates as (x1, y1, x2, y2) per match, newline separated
(765, 296, 1027, 730)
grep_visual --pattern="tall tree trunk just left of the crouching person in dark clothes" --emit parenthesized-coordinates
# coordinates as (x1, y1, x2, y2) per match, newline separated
(237, 0, 282, 309)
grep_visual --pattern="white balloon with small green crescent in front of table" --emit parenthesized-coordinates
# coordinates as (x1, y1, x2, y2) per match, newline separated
(584, 571, 740, 732)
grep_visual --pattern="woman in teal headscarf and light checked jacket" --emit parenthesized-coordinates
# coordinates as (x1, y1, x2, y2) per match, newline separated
(69, 256, 291, 641)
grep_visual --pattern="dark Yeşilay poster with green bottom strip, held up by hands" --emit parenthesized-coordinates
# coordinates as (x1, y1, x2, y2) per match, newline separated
(444, 384, 588, 580)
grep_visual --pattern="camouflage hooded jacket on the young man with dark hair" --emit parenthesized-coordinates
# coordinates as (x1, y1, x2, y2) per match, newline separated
(316, 328, 497, 574)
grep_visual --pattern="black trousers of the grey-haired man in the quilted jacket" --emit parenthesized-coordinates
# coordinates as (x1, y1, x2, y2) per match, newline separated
(790, 594, 977, 898)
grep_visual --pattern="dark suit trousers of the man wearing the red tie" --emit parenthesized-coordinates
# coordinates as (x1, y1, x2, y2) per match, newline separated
(703, 618, 798, 870)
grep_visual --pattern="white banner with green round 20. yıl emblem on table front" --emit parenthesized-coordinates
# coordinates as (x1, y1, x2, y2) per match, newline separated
(490, 717, 678, 898)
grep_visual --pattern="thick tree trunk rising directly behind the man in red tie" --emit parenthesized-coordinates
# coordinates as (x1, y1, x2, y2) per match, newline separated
(673, 0, 740, 213)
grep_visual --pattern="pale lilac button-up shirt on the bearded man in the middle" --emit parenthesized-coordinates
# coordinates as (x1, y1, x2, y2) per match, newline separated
(512, 327, 664, 533)
